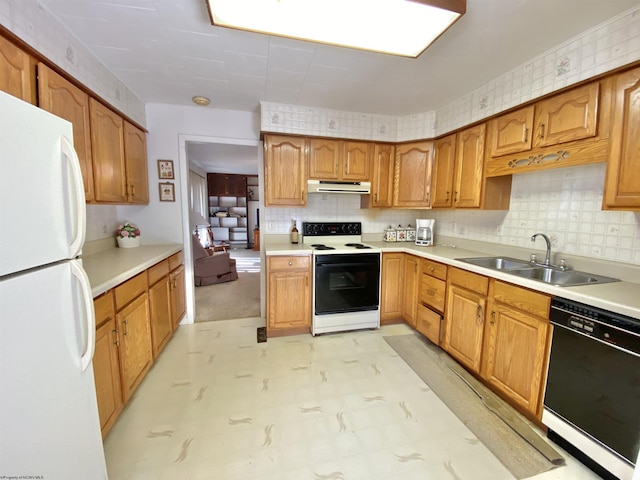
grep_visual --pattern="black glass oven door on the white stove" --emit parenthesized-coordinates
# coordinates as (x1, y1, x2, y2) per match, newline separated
(314, 253, 380, 315)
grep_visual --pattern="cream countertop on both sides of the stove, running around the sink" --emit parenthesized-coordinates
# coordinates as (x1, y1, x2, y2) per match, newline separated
(265, 239, 640, 319)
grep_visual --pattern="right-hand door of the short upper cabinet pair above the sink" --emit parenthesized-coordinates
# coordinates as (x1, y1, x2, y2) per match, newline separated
(533, 82, 600, 147)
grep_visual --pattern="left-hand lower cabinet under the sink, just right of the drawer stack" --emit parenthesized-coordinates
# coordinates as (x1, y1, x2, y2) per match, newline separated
(443, 268, 489, 373)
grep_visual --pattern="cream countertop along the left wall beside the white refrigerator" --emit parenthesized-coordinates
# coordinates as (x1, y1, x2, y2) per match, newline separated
(82, 244, 182, 298)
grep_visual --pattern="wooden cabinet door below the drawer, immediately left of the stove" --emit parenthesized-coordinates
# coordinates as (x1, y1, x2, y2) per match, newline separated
(267, 270, 311, 330)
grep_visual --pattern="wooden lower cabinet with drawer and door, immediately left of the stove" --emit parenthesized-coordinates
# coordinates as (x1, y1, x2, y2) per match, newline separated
(267, 255, 312, 337)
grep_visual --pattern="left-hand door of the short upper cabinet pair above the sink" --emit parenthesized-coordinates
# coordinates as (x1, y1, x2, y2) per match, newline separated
(489, 105, 534, 157)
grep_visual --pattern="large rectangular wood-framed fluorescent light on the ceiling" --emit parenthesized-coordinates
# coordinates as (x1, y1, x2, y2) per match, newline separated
(207, 0, 466, 58)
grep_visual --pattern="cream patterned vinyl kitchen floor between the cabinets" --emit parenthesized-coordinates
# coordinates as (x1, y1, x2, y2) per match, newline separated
(105, 318, 599, 480)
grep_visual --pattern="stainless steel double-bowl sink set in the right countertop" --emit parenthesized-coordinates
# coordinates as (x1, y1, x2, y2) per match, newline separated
(456, 257, 620, 287)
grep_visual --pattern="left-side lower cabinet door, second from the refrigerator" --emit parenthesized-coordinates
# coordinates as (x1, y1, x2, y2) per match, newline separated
(116, 292, 153, 402)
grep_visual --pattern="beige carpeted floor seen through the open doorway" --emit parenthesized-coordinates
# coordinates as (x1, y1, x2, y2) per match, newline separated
(195, 249, 260, 322)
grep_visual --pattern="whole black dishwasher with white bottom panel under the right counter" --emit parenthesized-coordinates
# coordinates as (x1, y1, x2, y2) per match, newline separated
(542, 297, 640, 480)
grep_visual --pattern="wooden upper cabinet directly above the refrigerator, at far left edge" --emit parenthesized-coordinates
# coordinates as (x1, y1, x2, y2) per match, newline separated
(0, 37, 36, 104)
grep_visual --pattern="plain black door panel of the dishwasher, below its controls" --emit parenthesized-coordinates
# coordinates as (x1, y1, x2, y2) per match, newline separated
(543, 321, 640, 470)
